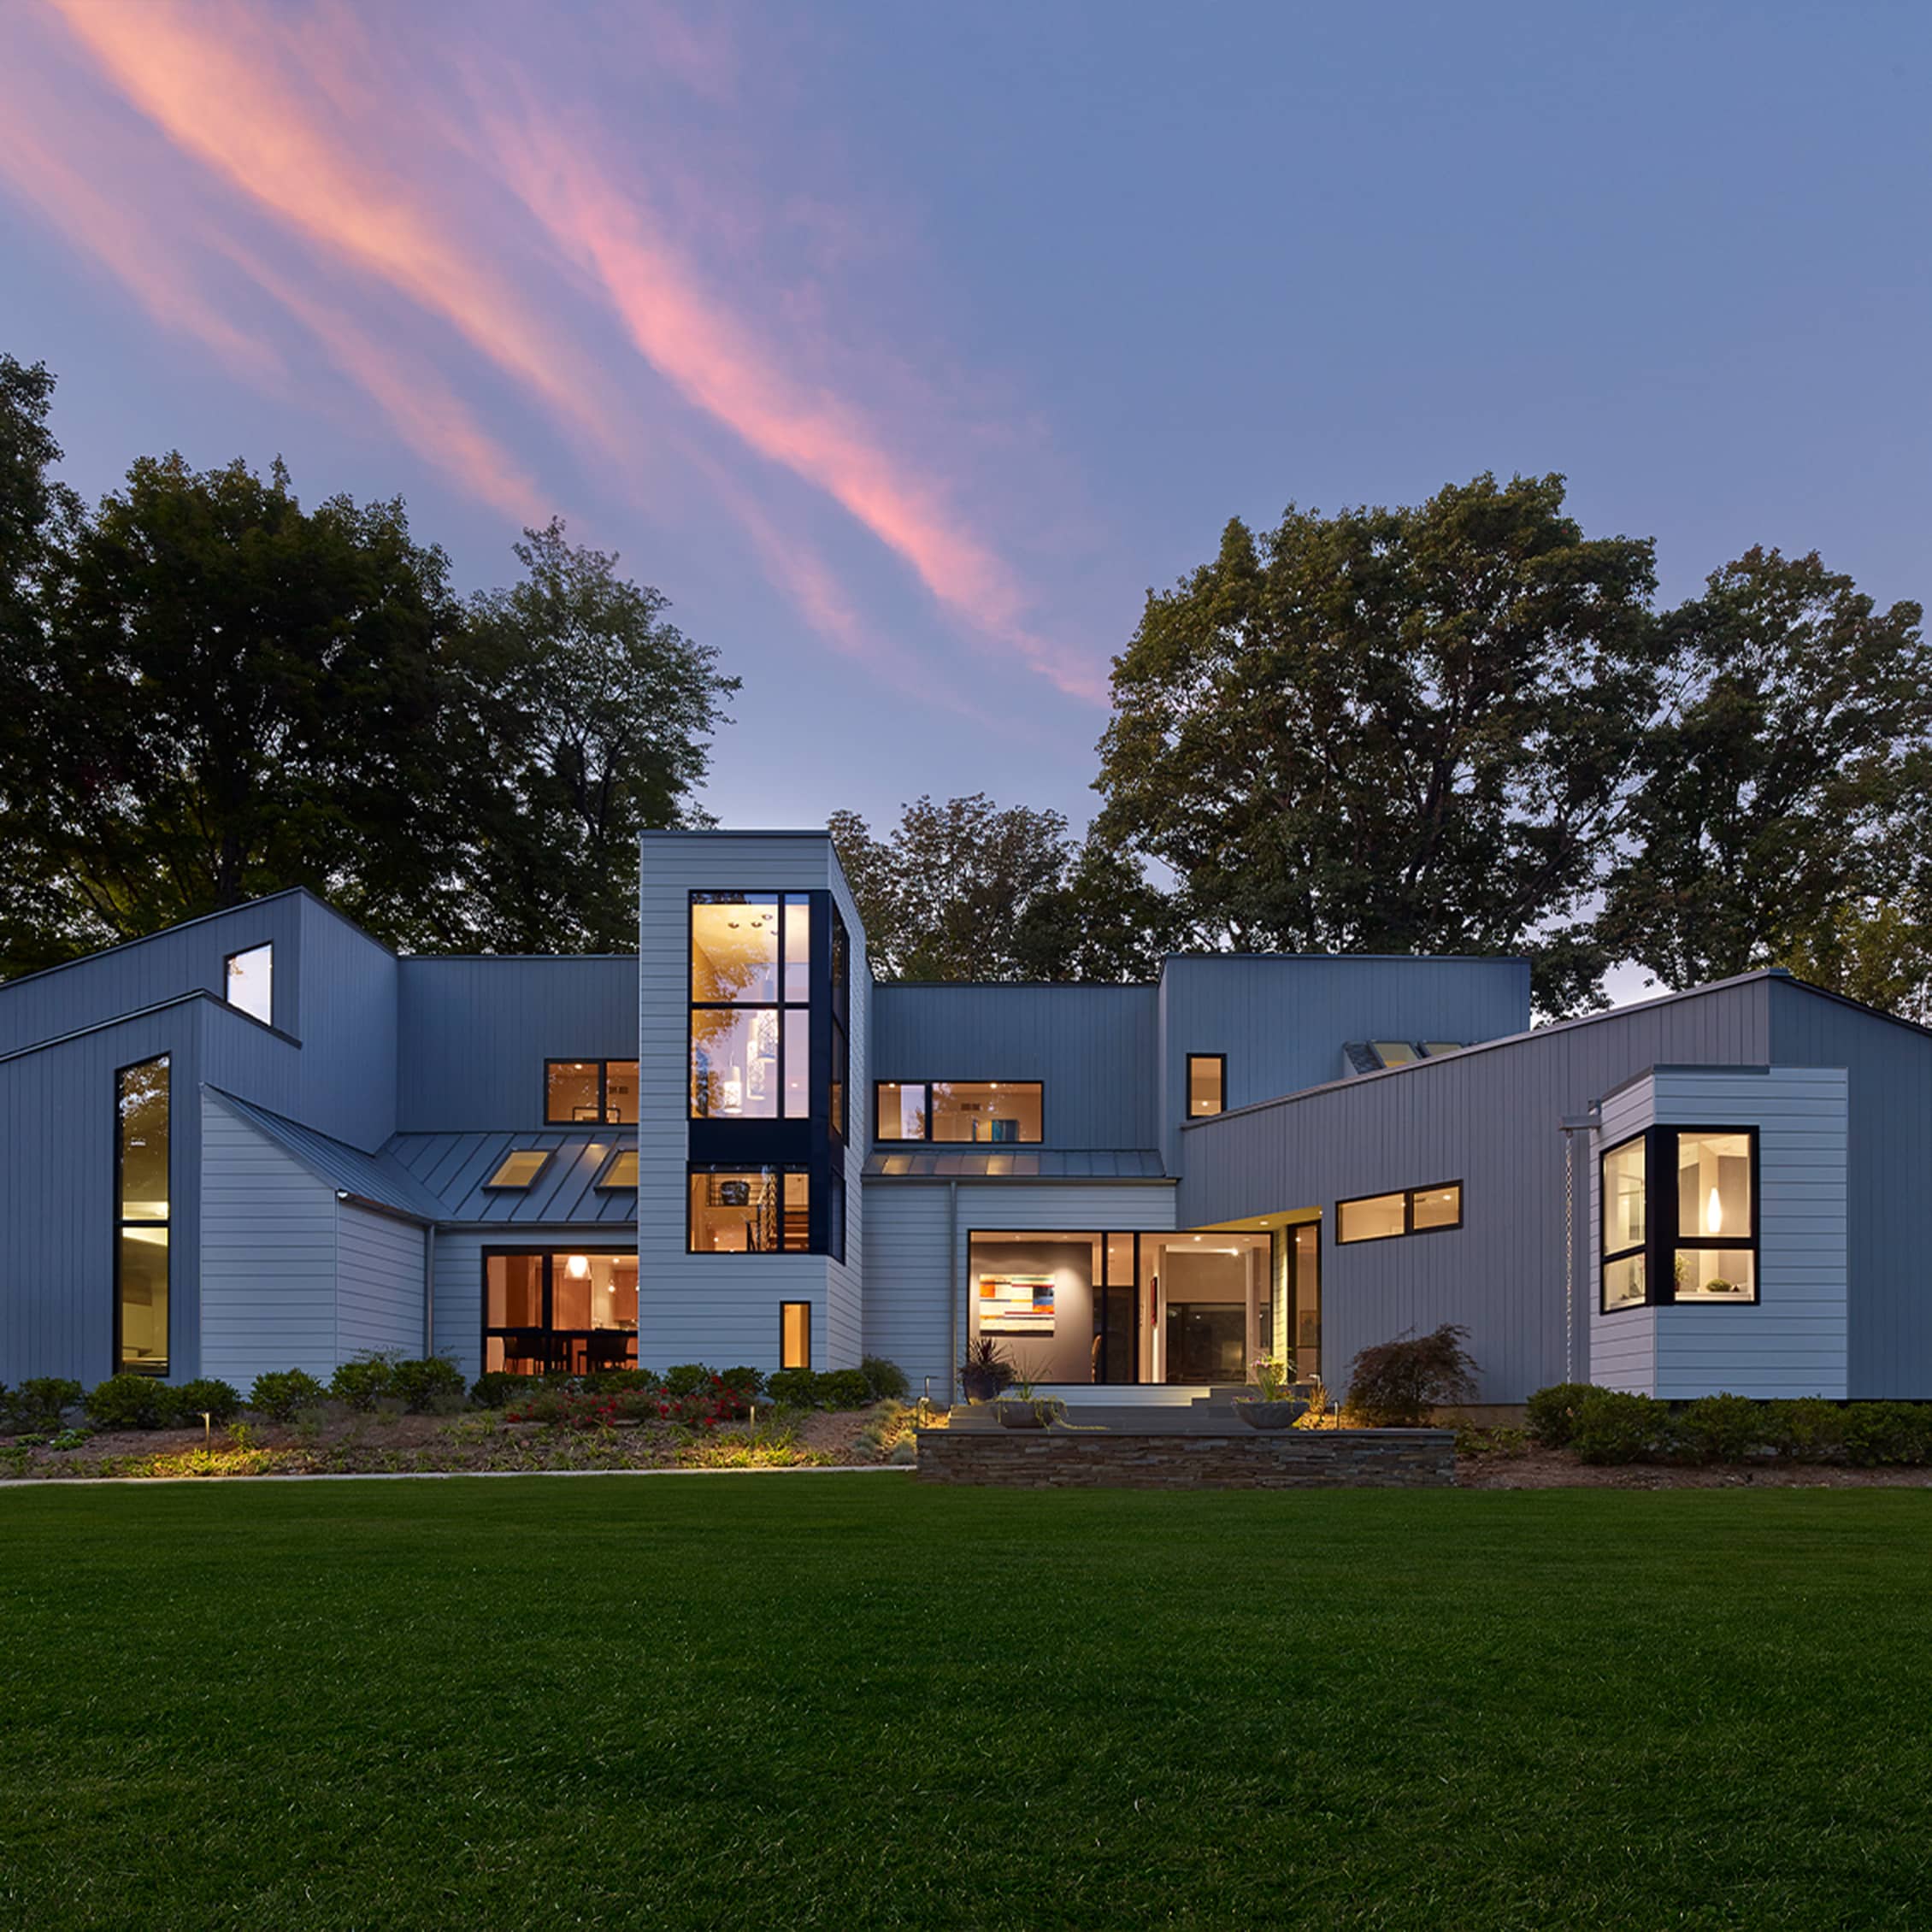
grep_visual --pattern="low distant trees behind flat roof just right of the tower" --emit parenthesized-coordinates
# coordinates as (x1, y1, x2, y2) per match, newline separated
(829, 792, 1167, 980)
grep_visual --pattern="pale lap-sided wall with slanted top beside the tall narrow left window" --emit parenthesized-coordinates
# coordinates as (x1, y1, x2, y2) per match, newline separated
(201, 1092, 340, 1395)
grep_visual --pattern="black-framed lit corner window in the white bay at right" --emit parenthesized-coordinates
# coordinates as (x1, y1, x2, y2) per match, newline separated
(1598, 1127, 1758, 1314)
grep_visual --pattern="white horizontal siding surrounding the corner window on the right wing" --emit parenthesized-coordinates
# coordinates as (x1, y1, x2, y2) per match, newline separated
(1590, 1067, 1849, 1401)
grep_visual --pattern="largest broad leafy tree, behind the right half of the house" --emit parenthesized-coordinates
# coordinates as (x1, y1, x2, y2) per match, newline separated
(1095, 475, 1656, 1010)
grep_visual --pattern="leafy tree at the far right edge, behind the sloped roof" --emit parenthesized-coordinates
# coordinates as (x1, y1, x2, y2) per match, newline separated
(1598, 549, 1932, 1006)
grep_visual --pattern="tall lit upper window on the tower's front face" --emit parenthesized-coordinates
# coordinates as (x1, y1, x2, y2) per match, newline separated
(692, 892, 811, 1121)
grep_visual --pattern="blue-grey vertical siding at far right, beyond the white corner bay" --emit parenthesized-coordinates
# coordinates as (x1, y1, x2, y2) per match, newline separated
(1771, 980, 1932, 1401)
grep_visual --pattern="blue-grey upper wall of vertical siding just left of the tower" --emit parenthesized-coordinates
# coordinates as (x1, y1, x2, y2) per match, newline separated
(396, 957, 638, 1134)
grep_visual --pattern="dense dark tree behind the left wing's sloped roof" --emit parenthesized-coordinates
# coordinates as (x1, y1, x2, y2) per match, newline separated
(0, 444, 462, 974)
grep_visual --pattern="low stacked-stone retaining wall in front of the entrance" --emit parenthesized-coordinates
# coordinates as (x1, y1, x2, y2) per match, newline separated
(918, 1428, 1455, 1489)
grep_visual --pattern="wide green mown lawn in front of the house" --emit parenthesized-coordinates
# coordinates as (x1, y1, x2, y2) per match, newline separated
(0, 1476, 1932, 1932)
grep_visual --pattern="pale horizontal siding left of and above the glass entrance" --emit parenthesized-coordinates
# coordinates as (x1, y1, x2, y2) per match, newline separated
(865, 1181, 1175, 1399)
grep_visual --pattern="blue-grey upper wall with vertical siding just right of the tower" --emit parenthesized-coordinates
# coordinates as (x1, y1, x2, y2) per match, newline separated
(863, 986, 1159, 1147)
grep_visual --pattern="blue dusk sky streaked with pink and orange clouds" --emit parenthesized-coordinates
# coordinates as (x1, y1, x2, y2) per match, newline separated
(0, 0, 1932, 842)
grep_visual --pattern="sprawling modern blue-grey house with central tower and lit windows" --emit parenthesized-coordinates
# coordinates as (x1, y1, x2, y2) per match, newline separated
(0, 833, 1932, 1403)
